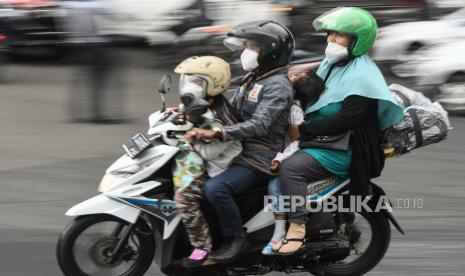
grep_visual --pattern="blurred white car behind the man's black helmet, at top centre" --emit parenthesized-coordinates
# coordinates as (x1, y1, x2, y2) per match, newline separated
(105, 0, 289, 46)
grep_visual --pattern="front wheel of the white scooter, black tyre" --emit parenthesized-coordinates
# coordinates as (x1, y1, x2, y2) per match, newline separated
(56, 214, 155, 276)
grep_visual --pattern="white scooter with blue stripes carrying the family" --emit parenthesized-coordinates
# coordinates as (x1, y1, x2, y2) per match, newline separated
(56, 75, 403, 276)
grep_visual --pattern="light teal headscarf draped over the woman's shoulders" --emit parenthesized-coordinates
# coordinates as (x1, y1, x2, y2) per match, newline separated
(305, 54, 404, 129)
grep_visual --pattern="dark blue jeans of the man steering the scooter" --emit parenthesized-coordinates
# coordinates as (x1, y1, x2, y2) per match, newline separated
(204, 165, 267, 237)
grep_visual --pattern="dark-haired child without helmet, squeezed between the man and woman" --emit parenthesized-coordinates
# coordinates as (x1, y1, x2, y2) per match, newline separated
(262, 68, 325, 255)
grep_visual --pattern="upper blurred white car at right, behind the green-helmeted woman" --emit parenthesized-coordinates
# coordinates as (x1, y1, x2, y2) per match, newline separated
(373, 8, 465, 62)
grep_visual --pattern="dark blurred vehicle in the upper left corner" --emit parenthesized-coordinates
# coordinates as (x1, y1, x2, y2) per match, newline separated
(0, 0, 67, 54)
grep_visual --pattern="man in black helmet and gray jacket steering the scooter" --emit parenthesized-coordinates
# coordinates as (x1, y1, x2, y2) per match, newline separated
(188, 21, 295, 262)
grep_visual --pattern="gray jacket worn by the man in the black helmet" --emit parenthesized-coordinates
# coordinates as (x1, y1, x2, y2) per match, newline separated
(223, 68, 294, 175)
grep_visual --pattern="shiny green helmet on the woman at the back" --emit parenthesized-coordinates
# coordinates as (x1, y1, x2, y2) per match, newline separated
(313, 7, 378, 56)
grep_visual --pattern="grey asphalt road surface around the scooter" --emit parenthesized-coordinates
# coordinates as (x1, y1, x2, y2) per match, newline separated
(0, 50, 465, 276)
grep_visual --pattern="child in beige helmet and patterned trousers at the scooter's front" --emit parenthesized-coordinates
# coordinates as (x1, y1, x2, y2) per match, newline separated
(173, 56, 242, 267)
